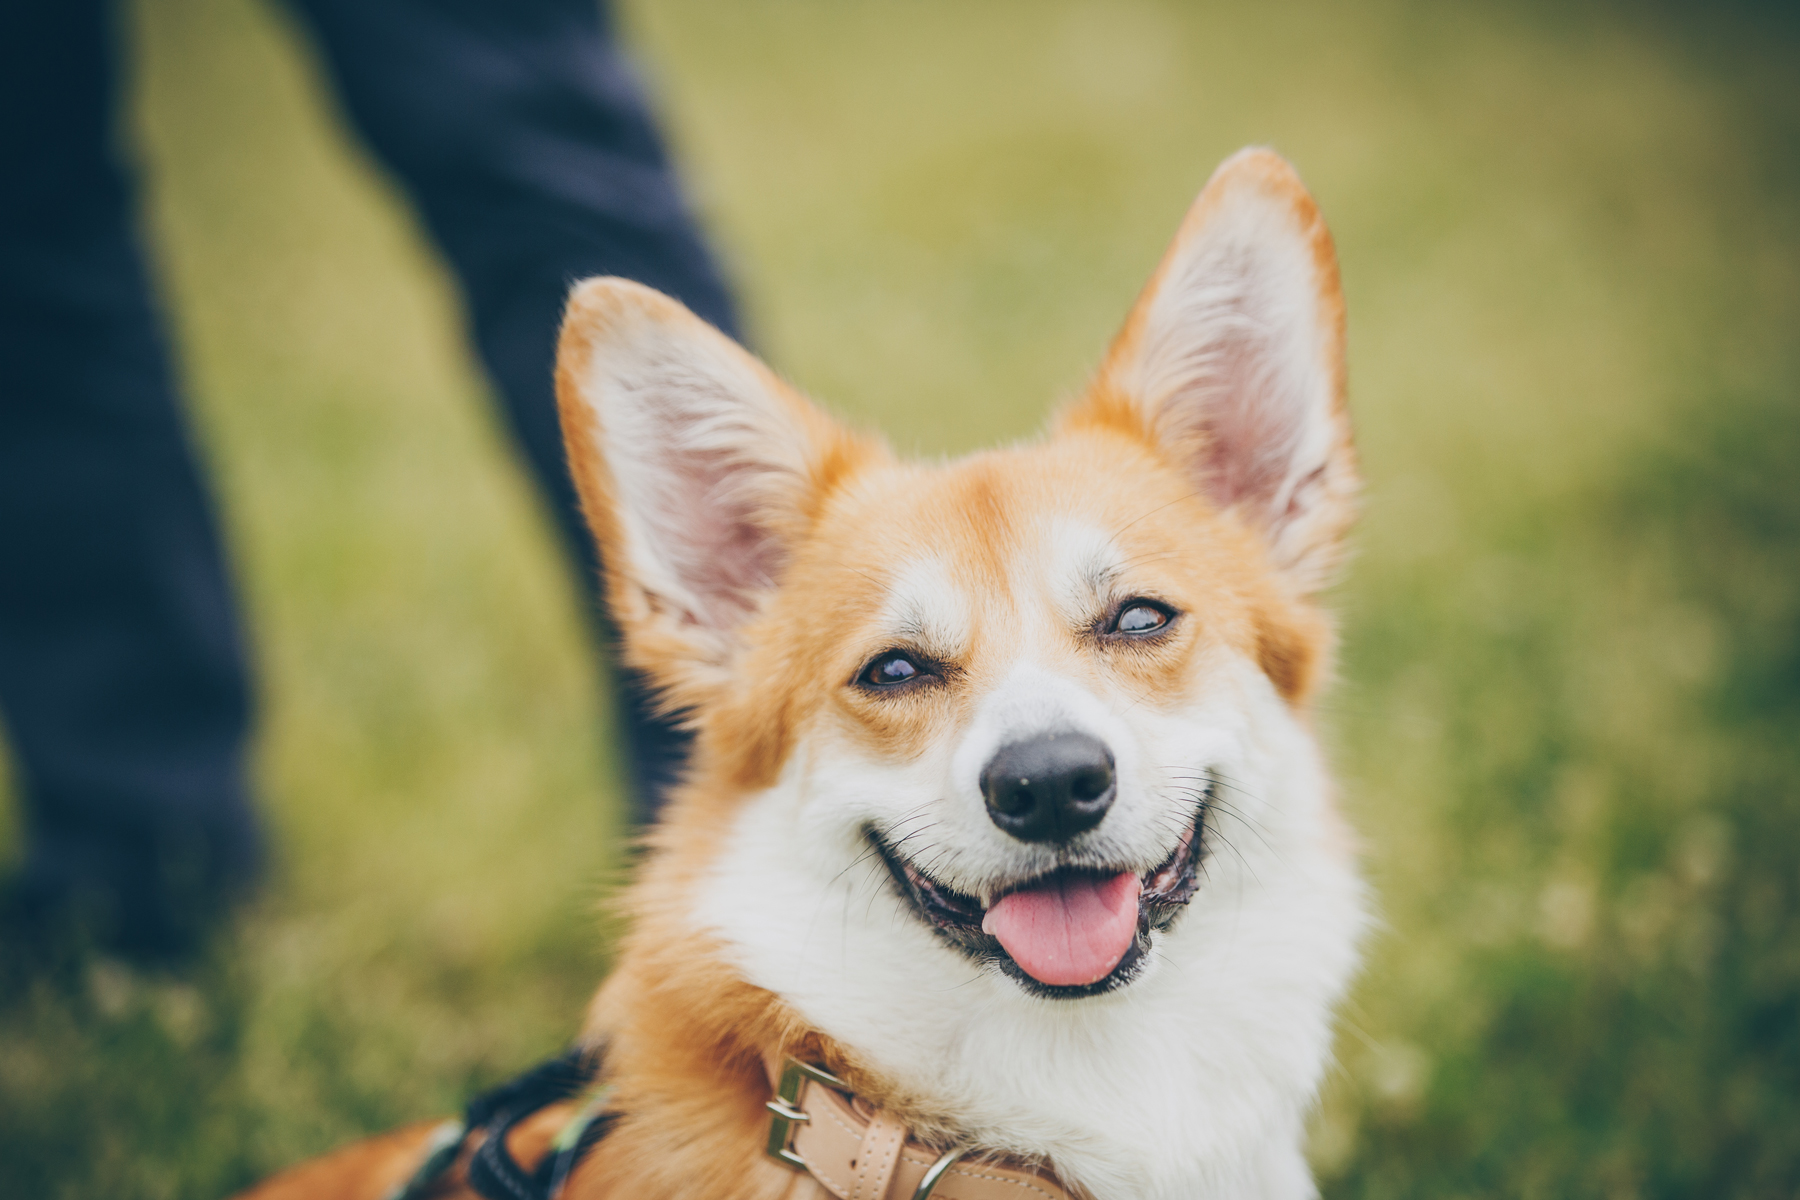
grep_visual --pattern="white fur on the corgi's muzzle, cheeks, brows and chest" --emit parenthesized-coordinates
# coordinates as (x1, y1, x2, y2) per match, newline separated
(695, 527, 1364, 1200)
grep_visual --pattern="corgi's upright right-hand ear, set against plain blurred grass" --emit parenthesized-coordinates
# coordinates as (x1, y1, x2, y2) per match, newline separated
(1064, 149, 1357, 594)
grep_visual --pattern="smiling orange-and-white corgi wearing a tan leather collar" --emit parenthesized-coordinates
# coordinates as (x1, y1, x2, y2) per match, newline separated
(239, 149, 1368, 1200)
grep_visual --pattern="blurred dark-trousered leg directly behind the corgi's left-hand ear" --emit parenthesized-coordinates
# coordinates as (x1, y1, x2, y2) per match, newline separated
(292, 0, 738, 820)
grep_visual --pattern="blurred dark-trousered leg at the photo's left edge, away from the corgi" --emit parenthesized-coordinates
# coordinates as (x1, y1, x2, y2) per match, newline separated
(0, 0, 259, 954)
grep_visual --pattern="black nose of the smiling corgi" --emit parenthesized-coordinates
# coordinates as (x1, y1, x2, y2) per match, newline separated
(981, 732, 1116, 842)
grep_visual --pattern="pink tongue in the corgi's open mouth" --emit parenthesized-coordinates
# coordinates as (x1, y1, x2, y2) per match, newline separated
(981, 871, 1143, 988)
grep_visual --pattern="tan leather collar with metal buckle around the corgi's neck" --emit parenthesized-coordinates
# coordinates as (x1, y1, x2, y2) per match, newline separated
(763, 1052, 1078, 1200)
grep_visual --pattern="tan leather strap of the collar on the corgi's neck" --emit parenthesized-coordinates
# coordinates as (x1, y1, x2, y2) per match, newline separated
(767, 1054, 1076, 1200)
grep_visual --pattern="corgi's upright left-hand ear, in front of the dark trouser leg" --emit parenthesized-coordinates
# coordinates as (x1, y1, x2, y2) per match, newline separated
(556, 279, 873, 709)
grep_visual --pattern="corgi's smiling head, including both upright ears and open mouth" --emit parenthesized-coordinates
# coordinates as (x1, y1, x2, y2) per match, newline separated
(558, 151, 1357, 999)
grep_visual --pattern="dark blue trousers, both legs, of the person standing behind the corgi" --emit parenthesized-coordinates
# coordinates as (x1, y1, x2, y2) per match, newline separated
(0, 0, 716, 948)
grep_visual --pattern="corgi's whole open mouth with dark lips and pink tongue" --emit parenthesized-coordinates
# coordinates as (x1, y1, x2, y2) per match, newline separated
(869, 802, 1208, 999)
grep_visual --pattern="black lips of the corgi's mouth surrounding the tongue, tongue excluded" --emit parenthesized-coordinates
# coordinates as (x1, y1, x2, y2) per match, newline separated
(868, 802, 1208, 1000)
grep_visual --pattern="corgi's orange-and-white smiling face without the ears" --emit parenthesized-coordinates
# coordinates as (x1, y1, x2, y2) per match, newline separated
(705, 432, 1339, 999)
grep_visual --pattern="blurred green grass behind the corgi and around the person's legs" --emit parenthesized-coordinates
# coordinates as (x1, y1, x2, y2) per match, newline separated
(0, 0, 1800, 1200)
